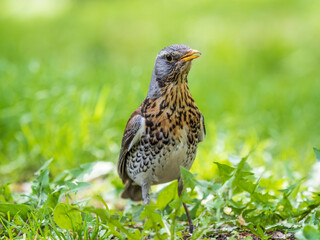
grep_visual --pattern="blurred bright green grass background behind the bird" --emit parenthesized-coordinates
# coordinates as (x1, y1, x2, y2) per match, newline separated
(0, 0, 320, 186)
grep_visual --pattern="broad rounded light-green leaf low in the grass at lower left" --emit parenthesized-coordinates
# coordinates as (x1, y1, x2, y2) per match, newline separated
(53, 203, 82, 230)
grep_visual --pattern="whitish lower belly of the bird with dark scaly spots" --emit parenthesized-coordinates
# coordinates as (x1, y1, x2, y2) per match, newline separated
(127, 126, 198, 185)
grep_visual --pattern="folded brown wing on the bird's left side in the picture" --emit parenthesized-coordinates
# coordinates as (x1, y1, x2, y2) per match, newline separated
(118, 107, 145, 183)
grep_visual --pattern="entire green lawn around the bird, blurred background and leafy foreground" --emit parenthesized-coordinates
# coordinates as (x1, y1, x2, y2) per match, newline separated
(0, 0, 320, 239)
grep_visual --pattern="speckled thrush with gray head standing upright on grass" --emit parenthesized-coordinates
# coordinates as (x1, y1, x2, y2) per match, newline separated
(117, 44, 206, 233)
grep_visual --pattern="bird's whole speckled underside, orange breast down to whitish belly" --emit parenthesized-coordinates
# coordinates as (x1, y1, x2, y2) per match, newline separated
(126, 83, 201, 188)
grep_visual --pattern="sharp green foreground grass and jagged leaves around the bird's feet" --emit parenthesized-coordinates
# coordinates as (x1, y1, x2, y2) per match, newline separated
(0, 156, 320, 240)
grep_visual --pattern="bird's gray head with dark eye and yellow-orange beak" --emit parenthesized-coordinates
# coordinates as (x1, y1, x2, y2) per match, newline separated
(147, 44, 201, 98)
